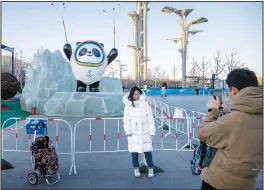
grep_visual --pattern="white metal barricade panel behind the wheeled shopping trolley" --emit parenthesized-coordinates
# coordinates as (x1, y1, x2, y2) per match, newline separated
(2, 118, 73, 176)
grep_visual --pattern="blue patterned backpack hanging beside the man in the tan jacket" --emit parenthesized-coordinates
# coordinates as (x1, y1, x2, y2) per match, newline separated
(190, 142, 207, 175)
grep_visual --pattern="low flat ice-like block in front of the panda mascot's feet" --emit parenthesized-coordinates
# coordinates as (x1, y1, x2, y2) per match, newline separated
(20, 92, 124, 117)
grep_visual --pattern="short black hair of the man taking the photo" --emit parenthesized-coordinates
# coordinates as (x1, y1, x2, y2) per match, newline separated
(226, 68, 258, 91)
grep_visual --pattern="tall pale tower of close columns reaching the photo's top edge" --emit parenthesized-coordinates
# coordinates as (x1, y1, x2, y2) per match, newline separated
(128, 2, 149, 80)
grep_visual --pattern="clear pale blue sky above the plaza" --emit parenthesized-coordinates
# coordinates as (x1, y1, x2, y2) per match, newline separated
(2, 2, 262, 78)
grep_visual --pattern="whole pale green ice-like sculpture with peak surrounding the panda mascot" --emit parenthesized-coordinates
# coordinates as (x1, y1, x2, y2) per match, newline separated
(20, 50, 124, 117)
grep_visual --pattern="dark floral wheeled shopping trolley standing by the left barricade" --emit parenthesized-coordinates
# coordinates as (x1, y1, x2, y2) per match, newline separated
(28, 122, 60, 185)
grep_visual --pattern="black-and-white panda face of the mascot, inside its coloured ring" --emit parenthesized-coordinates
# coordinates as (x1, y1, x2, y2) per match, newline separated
(75, 41, 105, 67)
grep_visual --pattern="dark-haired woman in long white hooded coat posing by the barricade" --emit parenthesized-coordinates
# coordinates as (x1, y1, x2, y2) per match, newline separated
(123, 87, 156, 177)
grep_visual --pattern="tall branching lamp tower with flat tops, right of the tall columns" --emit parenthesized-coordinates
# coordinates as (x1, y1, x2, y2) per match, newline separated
(162, 6, 208, 88)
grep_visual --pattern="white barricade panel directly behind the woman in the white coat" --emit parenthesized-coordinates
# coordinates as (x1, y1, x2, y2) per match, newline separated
(73, 117, 203, 174)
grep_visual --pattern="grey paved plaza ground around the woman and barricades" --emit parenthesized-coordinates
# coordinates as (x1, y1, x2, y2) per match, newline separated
(2, 96, 262, 189)
